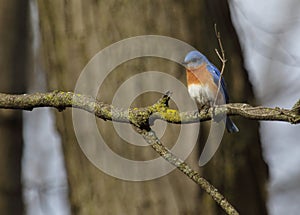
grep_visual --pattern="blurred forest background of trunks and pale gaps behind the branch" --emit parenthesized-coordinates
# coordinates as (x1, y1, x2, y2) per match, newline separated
(0, 0, 300, 215)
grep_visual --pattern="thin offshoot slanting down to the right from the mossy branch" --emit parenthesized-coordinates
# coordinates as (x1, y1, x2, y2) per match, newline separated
(136, 128, 239, 215)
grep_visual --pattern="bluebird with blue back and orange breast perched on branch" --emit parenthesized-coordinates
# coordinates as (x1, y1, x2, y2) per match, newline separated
(183, 51, 239, 133)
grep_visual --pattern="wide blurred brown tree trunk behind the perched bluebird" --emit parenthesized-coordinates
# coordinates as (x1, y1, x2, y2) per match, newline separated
(0, 0, 290, 214)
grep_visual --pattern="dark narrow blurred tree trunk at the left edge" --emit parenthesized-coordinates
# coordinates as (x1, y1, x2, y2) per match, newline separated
(0, 0, 28, 214)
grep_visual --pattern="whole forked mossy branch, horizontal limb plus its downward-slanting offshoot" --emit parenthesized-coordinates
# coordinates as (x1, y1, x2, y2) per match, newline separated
(0, 91, 300, 214)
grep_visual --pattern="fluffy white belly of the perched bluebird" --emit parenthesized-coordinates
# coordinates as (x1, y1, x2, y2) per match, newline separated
(188, 84, 215, 106)
